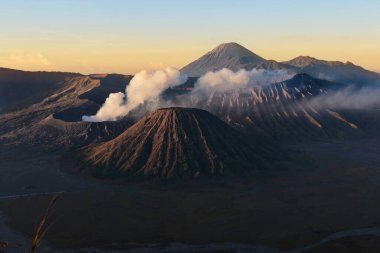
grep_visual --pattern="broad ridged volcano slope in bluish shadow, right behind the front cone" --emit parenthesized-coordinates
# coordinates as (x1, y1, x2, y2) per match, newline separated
(184, 74, 361, 140)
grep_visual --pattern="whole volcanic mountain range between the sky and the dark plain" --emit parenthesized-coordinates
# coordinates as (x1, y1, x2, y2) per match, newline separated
(0, 43, 380, 179)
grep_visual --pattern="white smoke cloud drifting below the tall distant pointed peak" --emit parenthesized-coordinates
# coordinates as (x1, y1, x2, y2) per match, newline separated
(193, 68, 293, 93)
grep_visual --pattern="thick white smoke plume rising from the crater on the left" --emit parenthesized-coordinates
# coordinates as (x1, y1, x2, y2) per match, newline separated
(82, 67, 187, 122)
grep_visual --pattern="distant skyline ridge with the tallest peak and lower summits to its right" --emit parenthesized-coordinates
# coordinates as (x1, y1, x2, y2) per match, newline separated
(181, 42, 380, 86)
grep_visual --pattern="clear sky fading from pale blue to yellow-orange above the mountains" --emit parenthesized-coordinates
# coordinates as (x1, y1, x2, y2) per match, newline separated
(0, 0, 380, 74)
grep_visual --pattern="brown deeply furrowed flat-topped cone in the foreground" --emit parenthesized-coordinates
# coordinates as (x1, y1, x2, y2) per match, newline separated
(85, 108, 273, 179)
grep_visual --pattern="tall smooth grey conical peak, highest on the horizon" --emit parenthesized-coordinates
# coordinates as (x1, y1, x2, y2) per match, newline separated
(181, 42, 266, 77)
